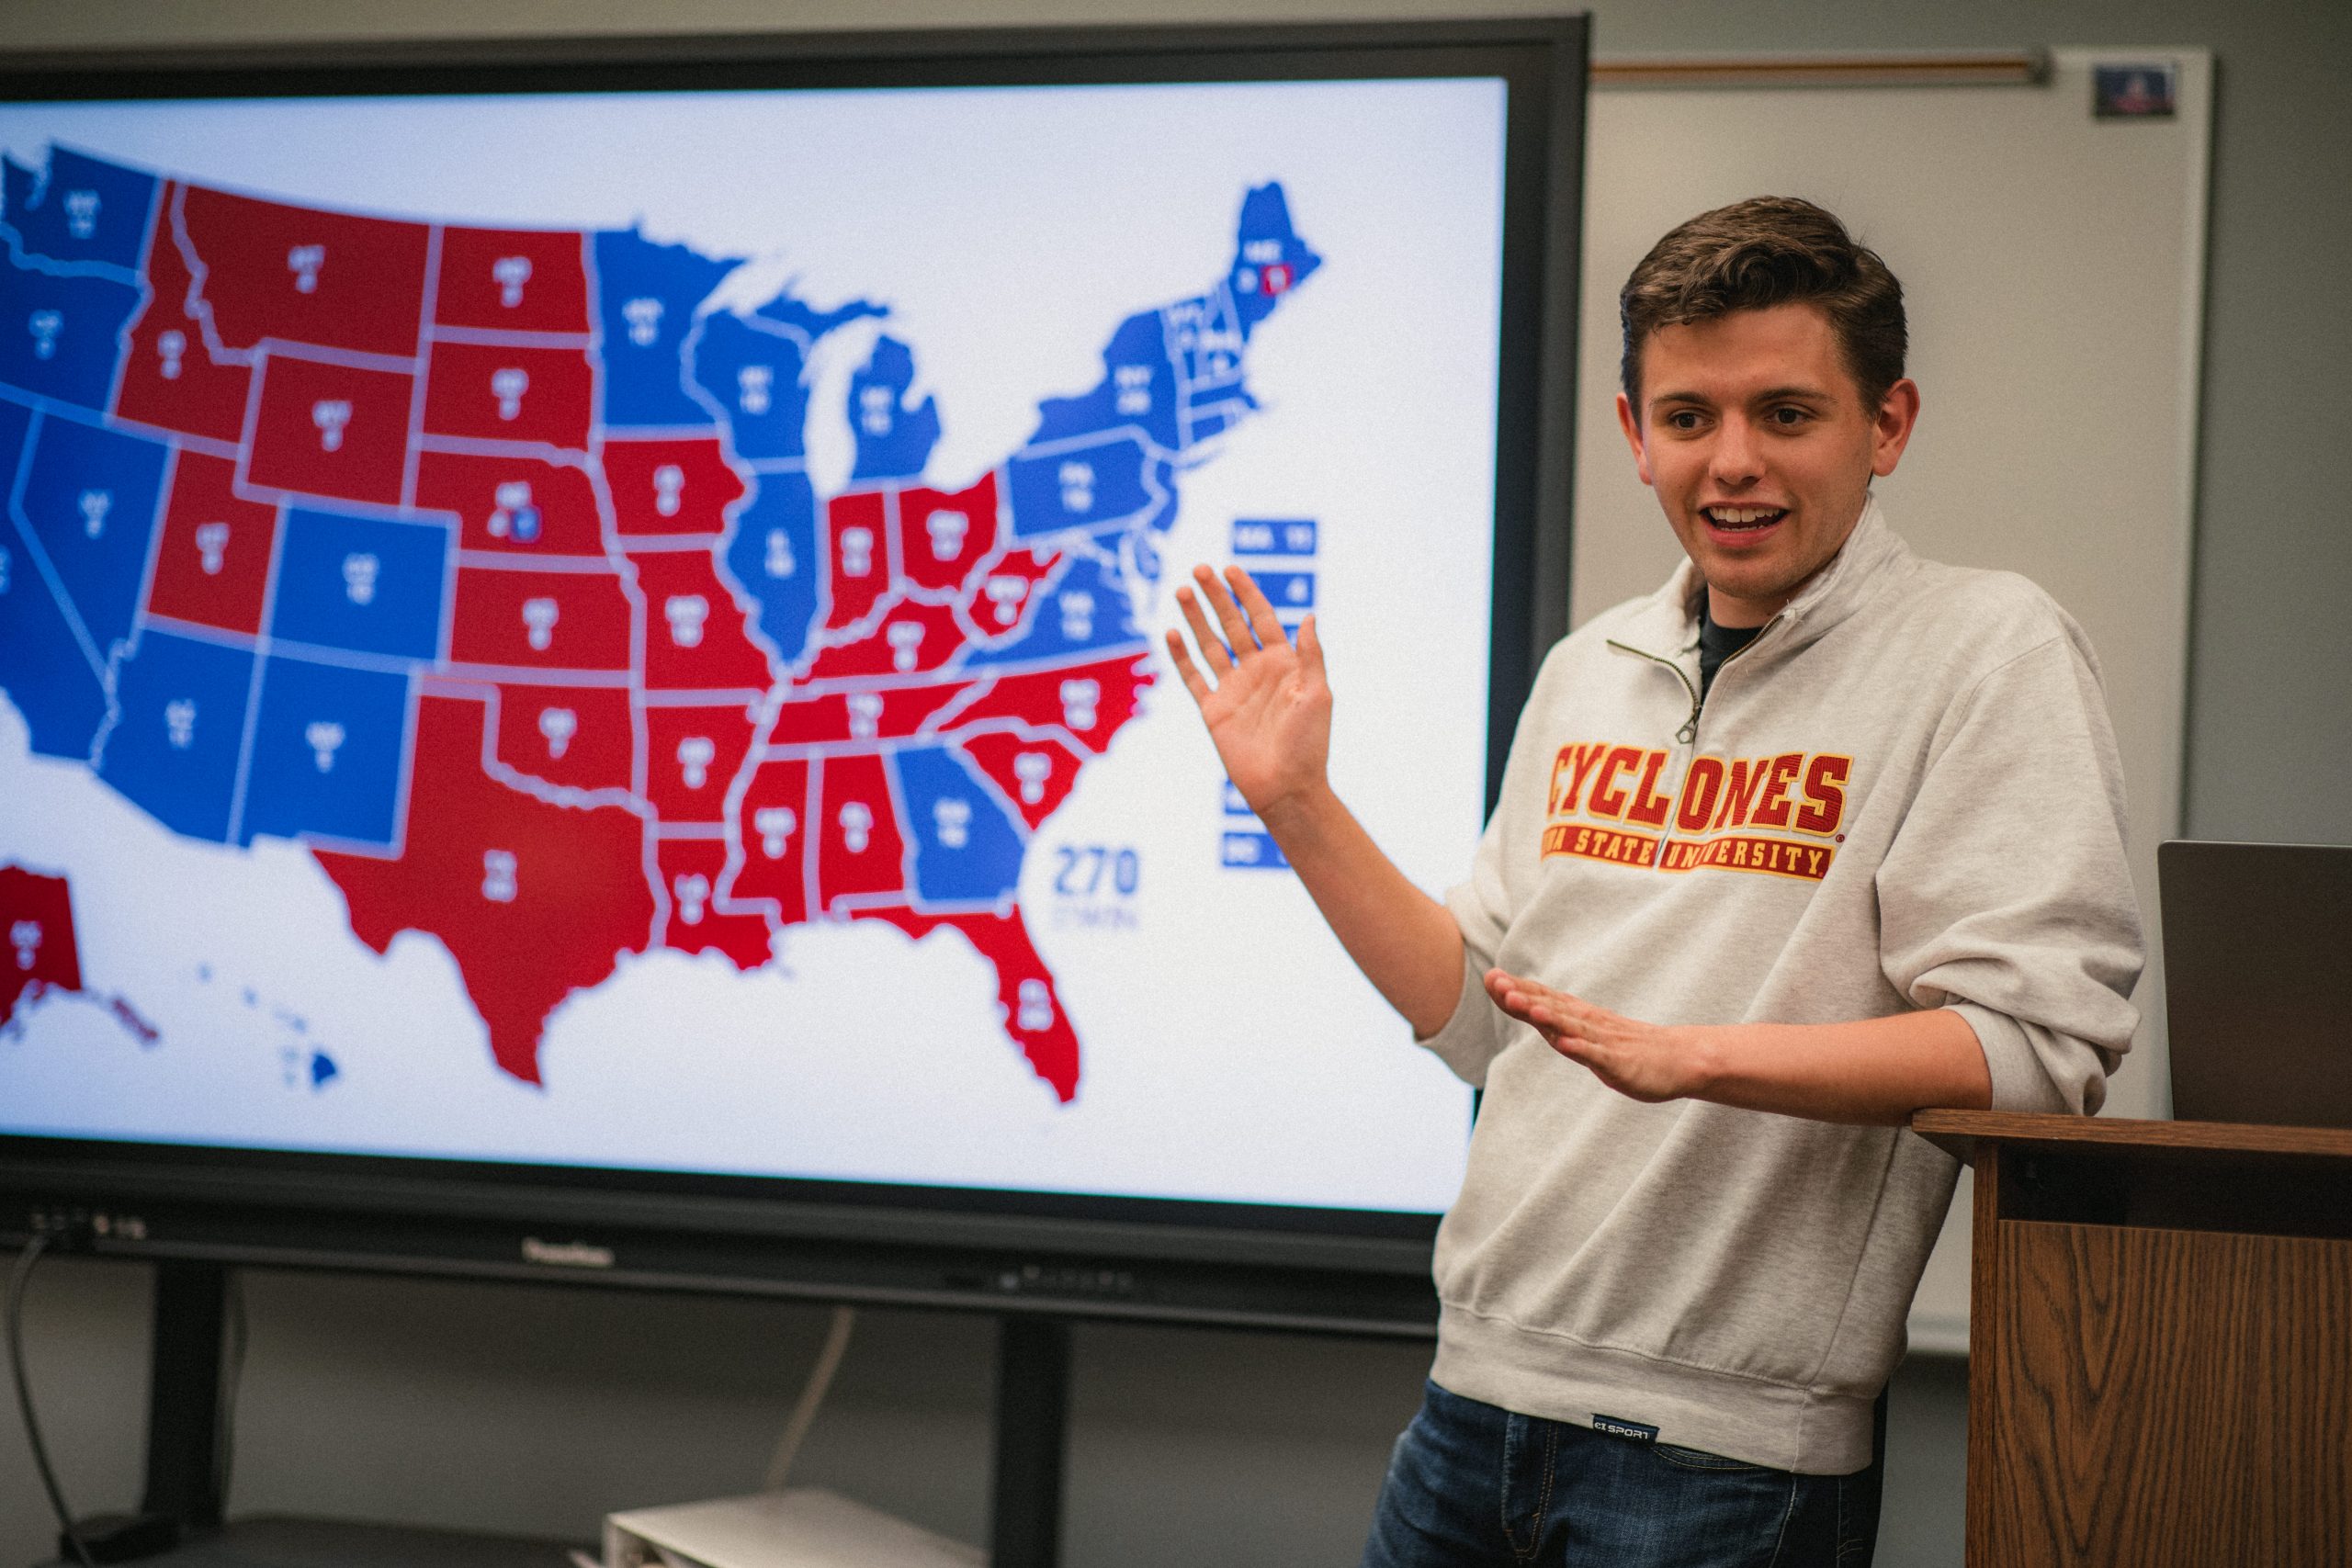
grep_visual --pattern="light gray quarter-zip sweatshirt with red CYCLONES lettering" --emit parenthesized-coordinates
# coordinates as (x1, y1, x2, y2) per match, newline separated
(1425, 501, 2143, 1474)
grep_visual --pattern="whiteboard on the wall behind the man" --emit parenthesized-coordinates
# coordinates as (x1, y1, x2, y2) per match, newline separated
(1569, 50, 2213, 1352)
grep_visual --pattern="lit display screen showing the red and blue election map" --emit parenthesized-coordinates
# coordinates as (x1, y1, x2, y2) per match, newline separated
(0, 24, 1580, 1288)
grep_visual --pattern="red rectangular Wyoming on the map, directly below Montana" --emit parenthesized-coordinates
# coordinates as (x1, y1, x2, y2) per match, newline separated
(244, 355, 416, 505)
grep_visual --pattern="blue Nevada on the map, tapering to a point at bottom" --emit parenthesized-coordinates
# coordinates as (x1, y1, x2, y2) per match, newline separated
(18, 413, 169, 653)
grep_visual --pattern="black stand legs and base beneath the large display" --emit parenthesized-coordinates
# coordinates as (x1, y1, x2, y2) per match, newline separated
(83, 1262, 1070, 1568)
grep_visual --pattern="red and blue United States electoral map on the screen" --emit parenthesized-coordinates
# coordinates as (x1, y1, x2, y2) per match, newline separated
(0, 146, 1319, 1100)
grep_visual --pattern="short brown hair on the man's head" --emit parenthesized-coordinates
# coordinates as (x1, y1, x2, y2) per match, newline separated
(1618, 195, 1910, 416)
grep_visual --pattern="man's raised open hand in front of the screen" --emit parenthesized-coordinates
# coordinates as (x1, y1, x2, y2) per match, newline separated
(1169, 567, 1331, 818)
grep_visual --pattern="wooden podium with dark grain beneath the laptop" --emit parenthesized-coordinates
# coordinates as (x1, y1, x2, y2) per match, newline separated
(1912, 1110, 2352, 1568)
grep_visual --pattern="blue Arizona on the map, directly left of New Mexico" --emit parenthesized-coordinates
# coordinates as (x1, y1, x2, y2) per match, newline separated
(99, 626, 254, 844)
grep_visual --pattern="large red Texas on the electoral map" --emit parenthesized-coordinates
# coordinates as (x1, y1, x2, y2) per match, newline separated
(312, 696, 654, 1084)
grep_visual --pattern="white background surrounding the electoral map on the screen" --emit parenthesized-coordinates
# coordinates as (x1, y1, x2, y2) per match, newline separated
(0, 80, 1503, 1211)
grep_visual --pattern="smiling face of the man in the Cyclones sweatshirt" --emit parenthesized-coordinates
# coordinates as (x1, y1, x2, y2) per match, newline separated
(1618, 306, 1919, 626)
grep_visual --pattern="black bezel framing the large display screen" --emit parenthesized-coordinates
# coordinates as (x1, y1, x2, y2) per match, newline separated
(0, 17, 1588, 1333)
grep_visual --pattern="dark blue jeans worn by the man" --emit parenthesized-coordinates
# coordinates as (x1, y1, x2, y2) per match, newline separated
(1362, 1382, 1882, 1568)
